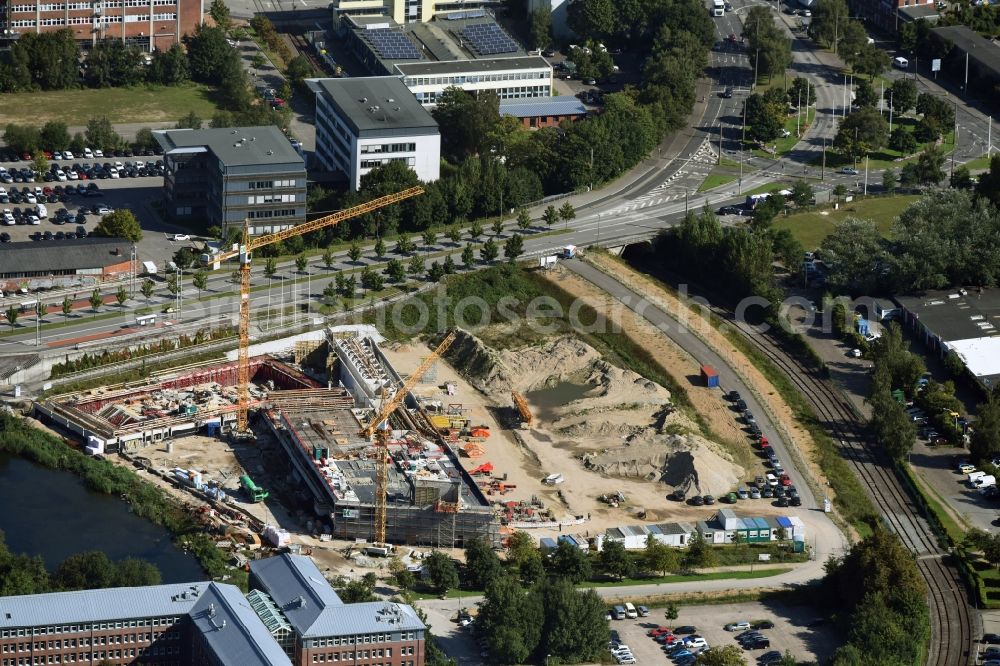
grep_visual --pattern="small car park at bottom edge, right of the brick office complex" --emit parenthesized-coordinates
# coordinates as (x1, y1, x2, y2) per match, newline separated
(610, 602, 839, 664)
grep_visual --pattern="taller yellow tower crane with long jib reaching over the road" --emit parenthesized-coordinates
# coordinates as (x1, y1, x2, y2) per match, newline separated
(212, 187, 424, 436)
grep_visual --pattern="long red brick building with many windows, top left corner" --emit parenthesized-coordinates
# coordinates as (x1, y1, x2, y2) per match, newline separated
(0, 0, 205, 52)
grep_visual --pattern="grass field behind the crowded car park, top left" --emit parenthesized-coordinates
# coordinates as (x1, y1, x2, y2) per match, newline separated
(0, 83, 218, 126)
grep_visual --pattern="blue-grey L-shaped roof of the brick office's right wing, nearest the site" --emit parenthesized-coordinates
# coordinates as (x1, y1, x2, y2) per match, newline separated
(250, 553, 424, 638)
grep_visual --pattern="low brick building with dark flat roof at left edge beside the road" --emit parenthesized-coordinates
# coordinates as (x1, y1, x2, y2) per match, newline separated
(0, 237, 134, 280)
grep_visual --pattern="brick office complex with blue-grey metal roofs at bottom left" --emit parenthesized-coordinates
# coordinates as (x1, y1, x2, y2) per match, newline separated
(0, 555, 425, 666)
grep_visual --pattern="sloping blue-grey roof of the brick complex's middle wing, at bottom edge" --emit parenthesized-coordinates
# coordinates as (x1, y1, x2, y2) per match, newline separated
(190, 583, 292, 666)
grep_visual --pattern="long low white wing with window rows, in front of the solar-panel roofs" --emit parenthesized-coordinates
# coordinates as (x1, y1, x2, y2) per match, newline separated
(395, 56, 552, 106)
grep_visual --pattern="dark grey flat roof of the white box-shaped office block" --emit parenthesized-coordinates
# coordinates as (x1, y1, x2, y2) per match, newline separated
(308, 76, 438, 135)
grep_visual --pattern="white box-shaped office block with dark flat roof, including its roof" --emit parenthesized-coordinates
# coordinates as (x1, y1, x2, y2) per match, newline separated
(308, 76, 441, 191)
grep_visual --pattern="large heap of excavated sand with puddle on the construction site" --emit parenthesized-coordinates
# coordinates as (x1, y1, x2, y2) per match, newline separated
(448, 332, 744, 495)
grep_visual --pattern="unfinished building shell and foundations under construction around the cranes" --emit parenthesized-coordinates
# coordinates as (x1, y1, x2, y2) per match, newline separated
(36, 328, 500, 552)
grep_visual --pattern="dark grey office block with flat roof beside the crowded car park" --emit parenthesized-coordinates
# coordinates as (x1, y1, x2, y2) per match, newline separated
(153, 125, 306, 235)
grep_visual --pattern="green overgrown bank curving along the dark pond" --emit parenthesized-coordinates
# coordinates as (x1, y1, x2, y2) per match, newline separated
(0, 414, 246, 589)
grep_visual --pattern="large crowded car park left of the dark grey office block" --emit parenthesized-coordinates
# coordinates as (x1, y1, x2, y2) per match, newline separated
(0, 156, 190, 265)
